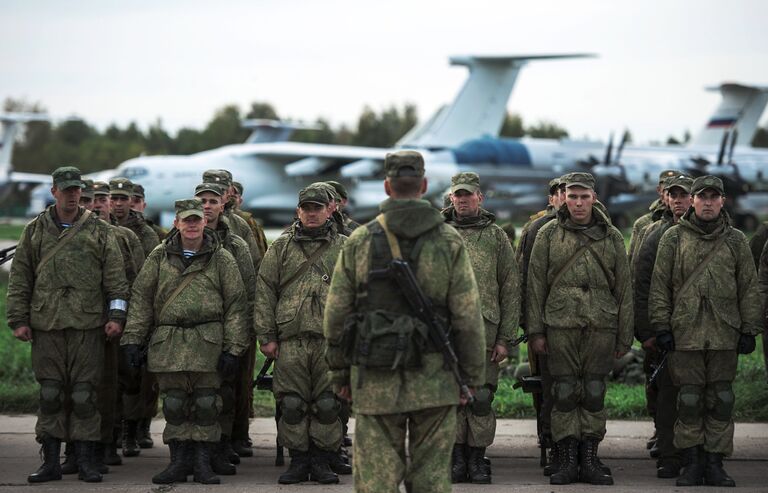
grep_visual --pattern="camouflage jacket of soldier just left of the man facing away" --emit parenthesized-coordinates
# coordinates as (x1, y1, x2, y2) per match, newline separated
(254, 221, 347, 344)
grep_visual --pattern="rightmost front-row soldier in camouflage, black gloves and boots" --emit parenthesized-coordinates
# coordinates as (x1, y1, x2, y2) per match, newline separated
(648, 175, 761, 486)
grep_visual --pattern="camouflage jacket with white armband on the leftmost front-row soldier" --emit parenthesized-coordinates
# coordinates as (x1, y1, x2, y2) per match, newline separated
(7, 205, 129, 331)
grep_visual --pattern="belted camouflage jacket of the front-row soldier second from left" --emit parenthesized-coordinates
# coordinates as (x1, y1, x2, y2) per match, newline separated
(120, 229, 248, 372)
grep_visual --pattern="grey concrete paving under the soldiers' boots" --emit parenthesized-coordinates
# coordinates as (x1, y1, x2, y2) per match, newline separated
(0, 416, 768, 493)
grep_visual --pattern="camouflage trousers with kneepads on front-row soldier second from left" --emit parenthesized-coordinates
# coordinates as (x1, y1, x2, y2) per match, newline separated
(154, 371, 222, 443)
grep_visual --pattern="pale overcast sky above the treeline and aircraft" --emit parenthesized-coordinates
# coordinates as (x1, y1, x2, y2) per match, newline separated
(0, 0, 768, 142)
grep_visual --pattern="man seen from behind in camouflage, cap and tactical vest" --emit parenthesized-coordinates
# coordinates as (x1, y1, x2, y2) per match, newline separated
(324, 151, 486, 493)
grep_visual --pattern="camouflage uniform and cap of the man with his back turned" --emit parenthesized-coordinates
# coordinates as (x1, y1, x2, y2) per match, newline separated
(324, 151, 486, 492)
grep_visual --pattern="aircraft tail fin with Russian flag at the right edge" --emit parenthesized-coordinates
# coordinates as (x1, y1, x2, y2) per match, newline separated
(690, 82, 768, 146)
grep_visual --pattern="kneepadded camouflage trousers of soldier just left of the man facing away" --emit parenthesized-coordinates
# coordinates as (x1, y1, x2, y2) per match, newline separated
(272, 335, 342, 452)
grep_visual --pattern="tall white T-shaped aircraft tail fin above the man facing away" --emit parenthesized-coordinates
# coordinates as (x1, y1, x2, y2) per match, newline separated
(397, 54, 593, 149)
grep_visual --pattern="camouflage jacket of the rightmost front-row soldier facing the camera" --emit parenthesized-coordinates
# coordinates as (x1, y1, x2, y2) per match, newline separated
(648, 208, 761, 351)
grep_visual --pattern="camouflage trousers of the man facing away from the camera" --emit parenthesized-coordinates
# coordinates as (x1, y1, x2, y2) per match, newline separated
(352, 406, 456, 493)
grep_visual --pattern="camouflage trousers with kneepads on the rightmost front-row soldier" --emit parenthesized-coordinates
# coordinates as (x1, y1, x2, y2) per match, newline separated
(667, 350, 738, 455)
